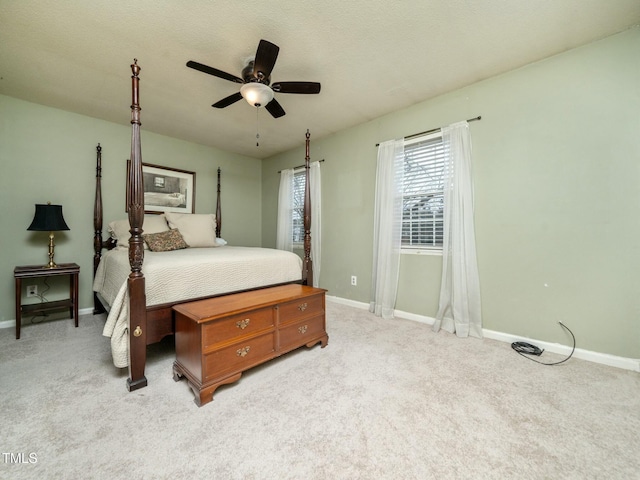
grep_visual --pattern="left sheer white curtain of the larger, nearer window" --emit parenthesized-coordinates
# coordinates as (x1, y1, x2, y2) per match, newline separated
(369, 139, 404, 318)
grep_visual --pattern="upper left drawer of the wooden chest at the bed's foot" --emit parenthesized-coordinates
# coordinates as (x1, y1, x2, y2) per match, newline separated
(202, 307, 275, 351)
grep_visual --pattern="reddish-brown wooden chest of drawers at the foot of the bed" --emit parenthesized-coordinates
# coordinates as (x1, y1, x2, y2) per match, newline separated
(173, 284, 329, 406)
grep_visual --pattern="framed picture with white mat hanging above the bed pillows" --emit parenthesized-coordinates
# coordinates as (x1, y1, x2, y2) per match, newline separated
(125, 160, 196, 213)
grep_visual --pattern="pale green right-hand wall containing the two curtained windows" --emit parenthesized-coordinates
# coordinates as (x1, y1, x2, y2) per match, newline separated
(262, 28, 640, 358)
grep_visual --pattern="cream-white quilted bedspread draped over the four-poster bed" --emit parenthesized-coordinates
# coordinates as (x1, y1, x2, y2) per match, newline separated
(93, 245, 302, 368)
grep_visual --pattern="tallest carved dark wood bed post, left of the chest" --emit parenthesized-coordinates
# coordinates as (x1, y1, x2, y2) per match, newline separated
(127, 59, 147, 391)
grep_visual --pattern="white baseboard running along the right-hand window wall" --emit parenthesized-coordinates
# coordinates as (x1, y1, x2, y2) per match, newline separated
(327, 295, 640, 372)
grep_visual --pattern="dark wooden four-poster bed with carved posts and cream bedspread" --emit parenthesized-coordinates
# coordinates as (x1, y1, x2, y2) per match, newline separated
(93, 60, 313, 391)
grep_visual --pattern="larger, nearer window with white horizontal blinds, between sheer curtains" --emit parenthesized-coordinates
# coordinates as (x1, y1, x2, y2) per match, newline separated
(402, 132, 445, 251)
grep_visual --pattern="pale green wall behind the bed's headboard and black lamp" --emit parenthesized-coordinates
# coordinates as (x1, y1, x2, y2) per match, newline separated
(0, 95, 261, 321)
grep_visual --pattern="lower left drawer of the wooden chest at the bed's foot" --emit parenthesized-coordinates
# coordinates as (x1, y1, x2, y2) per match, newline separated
(204, 333, 276, 382)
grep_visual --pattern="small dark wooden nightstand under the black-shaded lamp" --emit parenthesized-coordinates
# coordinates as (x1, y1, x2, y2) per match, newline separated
(13, 263, 80, 339)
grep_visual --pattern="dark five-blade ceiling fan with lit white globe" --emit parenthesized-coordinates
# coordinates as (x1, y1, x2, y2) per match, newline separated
(187, 40, 320, 118)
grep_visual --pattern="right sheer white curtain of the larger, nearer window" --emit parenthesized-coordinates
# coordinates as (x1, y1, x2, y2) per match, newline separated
(433, 122, 482, 338)
